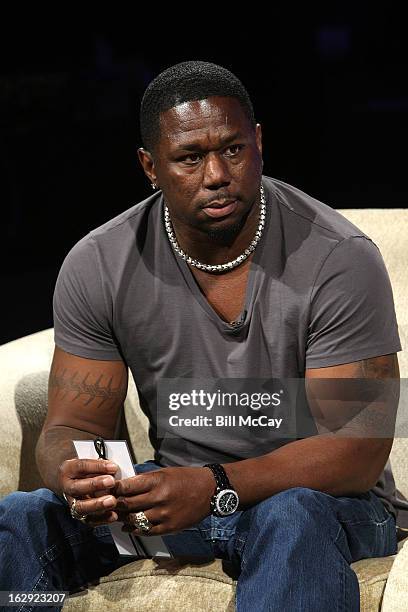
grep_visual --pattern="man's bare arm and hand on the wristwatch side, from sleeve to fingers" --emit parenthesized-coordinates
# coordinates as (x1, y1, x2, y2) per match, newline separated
(116, 354, 399, 535)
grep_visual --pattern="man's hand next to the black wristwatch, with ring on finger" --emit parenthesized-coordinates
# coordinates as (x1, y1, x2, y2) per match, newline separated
(114, 467, 215, 535)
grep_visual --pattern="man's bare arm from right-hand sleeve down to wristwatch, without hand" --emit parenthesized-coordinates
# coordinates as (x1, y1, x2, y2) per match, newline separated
(223, 354, 399, 507)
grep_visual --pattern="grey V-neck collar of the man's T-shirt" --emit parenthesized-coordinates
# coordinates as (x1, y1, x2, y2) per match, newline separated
(160, 186, 271, 335)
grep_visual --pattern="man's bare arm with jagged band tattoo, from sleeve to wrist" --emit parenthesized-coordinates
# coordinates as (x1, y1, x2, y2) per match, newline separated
(36, 347, 128, 493)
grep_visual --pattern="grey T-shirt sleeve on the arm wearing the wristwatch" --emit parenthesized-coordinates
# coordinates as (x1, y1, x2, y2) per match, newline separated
(306, 236, 401, 368)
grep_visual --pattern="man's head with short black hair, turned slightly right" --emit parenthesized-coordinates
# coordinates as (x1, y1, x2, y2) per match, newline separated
(139, 61, 262, 245)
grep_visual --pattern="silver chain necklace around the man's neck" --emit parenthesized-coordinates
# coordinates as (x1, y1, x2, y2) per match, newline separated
(164, 185, 266, 272)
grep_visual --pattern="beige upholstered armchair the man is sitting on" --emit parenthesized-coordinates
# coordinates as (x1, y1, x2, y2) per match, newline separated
(0, 210, 408, 612)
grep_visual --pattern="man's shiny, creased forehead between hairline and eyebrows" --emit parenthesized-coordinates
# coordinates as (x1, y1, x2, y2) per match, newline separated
(160, 96, 251, 145)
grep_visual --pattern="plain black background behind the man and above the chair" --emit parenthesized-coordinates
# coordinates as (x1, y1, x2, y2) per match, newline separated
(0, 8, 408, 343)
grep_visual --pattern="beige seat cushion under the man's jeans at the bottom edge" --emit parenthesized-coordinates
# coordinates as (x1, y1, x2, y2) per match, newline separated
(64, 539, 408, 612)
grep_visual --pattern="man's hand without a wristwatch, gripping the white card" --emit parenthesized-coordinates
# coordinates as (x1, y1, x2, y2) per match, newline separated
(58, 459, 118, 527)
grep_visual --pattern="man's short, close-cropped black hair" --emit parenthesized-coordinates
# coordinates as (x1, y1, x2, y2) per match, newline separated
(140, 61, 256, 151)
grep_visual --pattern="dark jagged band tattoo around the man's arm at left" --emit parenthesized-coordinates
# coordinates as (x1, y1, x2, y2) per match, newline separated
(49, 369, 125, 408)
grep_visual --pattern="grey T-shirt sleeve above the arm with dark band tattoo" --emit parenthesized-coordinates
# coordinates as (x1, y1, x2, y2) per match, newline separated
(53, 236, 122, 361)
